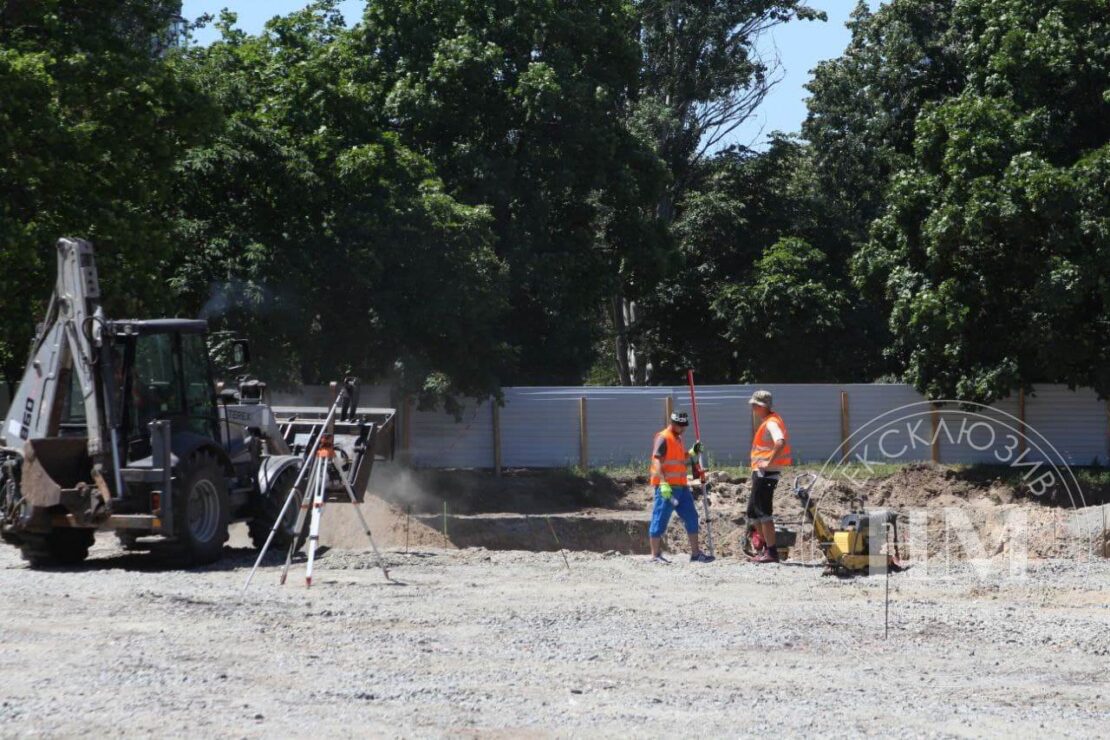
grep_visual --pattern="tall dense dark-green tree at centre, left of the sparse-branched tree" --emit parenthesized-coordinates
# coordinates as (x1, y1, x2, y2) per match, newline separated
(356, 0, 664, 383)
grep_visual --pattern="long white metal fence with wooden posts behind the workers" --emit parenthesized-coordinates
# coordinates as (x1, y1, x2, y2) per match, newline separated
(386, 384, 1110, 468)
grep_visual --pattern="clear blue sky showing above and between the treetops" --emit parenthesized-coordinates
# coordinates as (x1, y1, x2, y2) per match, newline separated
(183, 0, 879, 146)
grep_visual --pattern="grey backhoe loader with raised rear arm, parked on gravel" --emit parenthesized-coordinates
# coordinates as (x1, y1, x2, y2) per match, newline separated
(0, 237, 394, 566)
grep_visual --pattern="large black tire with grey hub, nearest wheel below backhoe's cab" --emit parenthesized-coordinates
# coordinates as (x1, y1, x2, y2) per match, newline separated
(167, 453, 231, 565)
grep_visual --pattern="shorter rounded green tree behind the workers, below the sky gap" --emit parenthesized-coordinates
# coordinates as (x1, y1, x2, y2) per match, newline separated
(645, 135, 881, 383)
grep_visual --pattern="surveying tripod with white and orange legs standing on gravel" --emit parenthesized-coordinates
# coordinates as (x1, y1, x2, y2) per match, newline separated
(243, 378, 393, 594)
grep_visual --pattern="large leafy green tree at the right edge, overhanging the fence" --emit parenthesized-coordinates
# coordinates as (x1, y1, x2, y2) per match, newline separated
(856, 0, 1110, 403)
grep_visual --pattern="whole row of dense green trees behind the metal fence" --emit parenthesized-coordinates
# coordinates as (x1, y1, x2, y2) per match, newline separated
(0, 0, 1110, 408)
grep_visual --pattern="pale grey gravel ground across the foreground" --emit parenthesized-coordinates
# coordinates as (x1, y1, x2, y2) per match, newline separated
(0, 537, 1110, 737)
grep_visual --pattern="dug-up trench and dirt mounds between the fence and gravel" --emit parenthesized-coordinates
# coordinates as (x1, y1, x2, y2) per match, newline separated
(321, 466, 1110, 559)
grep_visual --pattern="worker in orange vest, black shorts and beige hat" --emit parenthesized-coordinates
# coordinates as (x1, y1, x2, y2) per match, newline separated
(748, 391, 794, 562)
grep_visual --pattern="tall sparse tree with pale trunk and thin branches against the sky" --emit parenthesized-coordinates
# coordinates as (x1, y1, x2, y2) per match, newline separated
(609, 0, 825, 385)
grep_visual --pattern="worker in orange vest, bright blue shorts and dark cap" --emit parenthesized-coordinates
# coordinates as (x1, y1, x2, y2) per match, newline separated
(647, 412, 713, 562)
